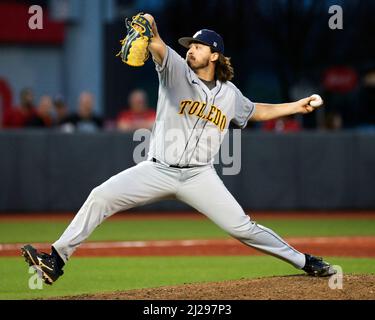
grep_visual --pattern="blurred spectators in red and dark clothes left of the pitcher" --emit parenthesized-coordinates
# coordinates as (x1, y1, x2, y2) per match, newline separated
(0, 88, 156, 133)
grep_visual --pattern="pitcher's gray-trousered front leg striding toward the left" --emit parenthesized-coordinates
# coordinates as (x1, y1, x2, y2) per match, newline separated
(52, 161, 178, 262)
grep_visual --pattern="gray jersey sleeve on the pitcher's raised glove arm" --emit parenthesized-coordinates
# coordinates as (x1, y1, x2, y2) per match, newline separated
(154, 46, 188, 87)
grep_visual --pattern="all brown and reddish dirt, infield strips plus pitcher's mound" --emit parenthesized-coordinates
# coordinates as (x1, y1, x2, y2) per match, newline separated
(0, 212, 375, 300)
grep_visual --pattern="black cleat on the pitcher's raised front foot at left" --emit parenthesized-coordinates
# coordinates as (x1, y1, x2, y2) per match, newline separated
(21, 244, 64, 284)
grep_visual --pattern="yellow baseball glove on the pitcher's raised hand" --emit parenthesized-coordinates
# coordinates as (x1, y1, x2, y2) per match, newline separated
(116, 12, 153, 67)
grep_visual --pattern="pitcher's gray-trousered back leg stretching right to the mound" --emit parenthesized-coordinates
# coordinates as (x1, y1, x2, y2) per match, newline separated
(177, 169, 305, 269)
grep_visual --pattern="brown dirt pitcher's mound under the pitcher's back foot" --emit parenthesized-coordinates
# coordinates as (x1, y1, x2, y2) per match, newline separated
(63, 275, 375, 300)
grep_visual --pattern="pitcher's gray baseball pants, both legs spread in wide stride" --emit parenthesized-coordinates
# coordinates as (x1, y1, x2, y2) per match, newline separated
(53, 161, 305, 269)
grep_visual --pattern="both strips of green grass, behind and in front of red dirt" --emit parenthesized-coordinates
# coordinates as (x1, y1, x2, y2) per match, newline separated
(0, 219, 375, 299)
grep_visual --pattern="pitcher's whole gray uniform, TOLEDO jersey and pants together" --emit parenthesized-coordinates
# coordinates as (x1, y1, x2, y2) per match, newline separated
(53, 47, 305, 269)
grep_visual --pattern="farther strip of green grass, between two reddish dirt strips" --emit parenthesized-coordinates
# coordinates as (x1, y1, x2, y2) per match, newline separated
(0, 219, 375, 243)
